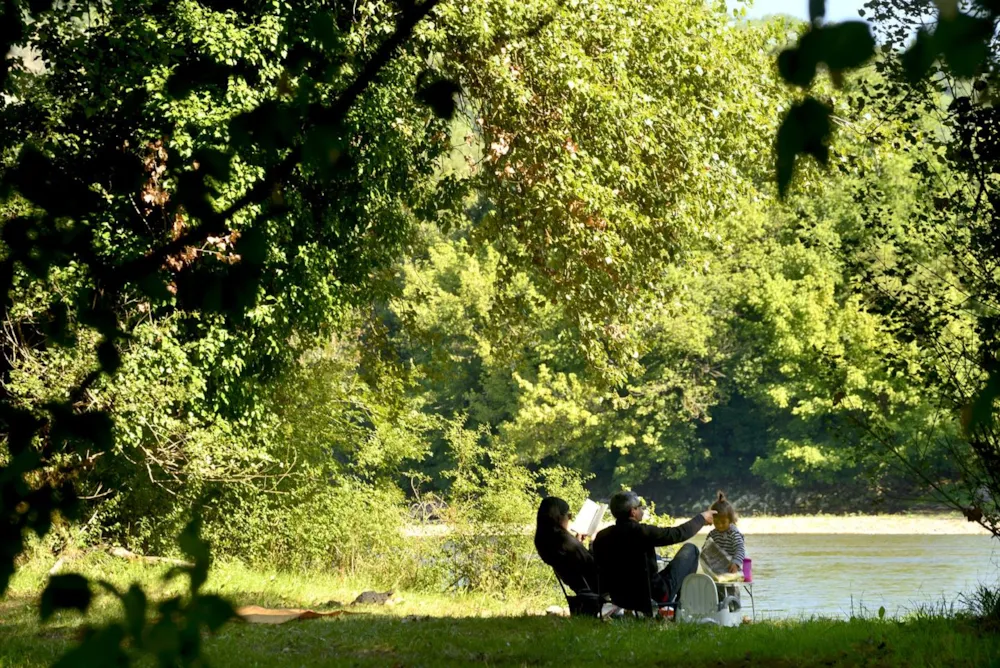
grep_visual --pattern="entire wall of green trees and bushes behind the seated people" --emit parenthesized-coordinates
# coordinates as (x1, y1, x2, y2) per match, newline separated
(0, 0, 996, 596)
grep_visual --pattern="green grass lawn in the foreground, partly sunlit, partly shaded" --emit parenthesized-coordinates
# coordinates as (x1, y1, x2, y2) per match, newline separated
(0, 555, 1000, 668)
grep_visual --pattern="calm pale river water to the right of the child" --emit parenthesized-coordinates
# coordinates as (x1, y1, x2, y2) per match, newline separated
(691, 532, 1000, 619)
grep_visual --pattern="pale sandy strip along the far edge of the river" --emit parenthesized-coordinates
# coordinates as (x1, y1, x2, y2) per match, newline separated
(403, 514, 989, 537)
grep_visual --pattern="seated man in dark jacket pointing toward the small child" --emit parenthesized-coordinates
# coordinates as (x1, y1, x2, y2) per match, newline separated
(593, 492, 715, 603)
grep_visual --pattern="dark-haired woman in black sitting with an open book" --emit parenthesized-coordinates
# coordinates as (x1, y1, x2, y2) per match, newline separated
(535, 496, 597, 594)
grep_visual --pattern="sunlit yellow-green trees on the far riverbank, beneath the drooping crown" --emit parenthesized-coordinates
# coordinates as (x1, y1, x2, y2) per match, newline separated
(387, 128, 964, 503)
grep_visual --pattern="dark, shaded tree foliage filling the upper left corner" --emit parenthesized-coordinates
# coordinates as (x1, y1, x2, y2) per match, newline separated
(0, 0, 450, 632)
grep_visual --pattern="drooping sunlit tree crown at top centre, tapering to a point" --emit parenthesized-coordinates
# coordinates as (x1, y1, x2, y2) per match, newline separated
(434, 0, 784, 382)
